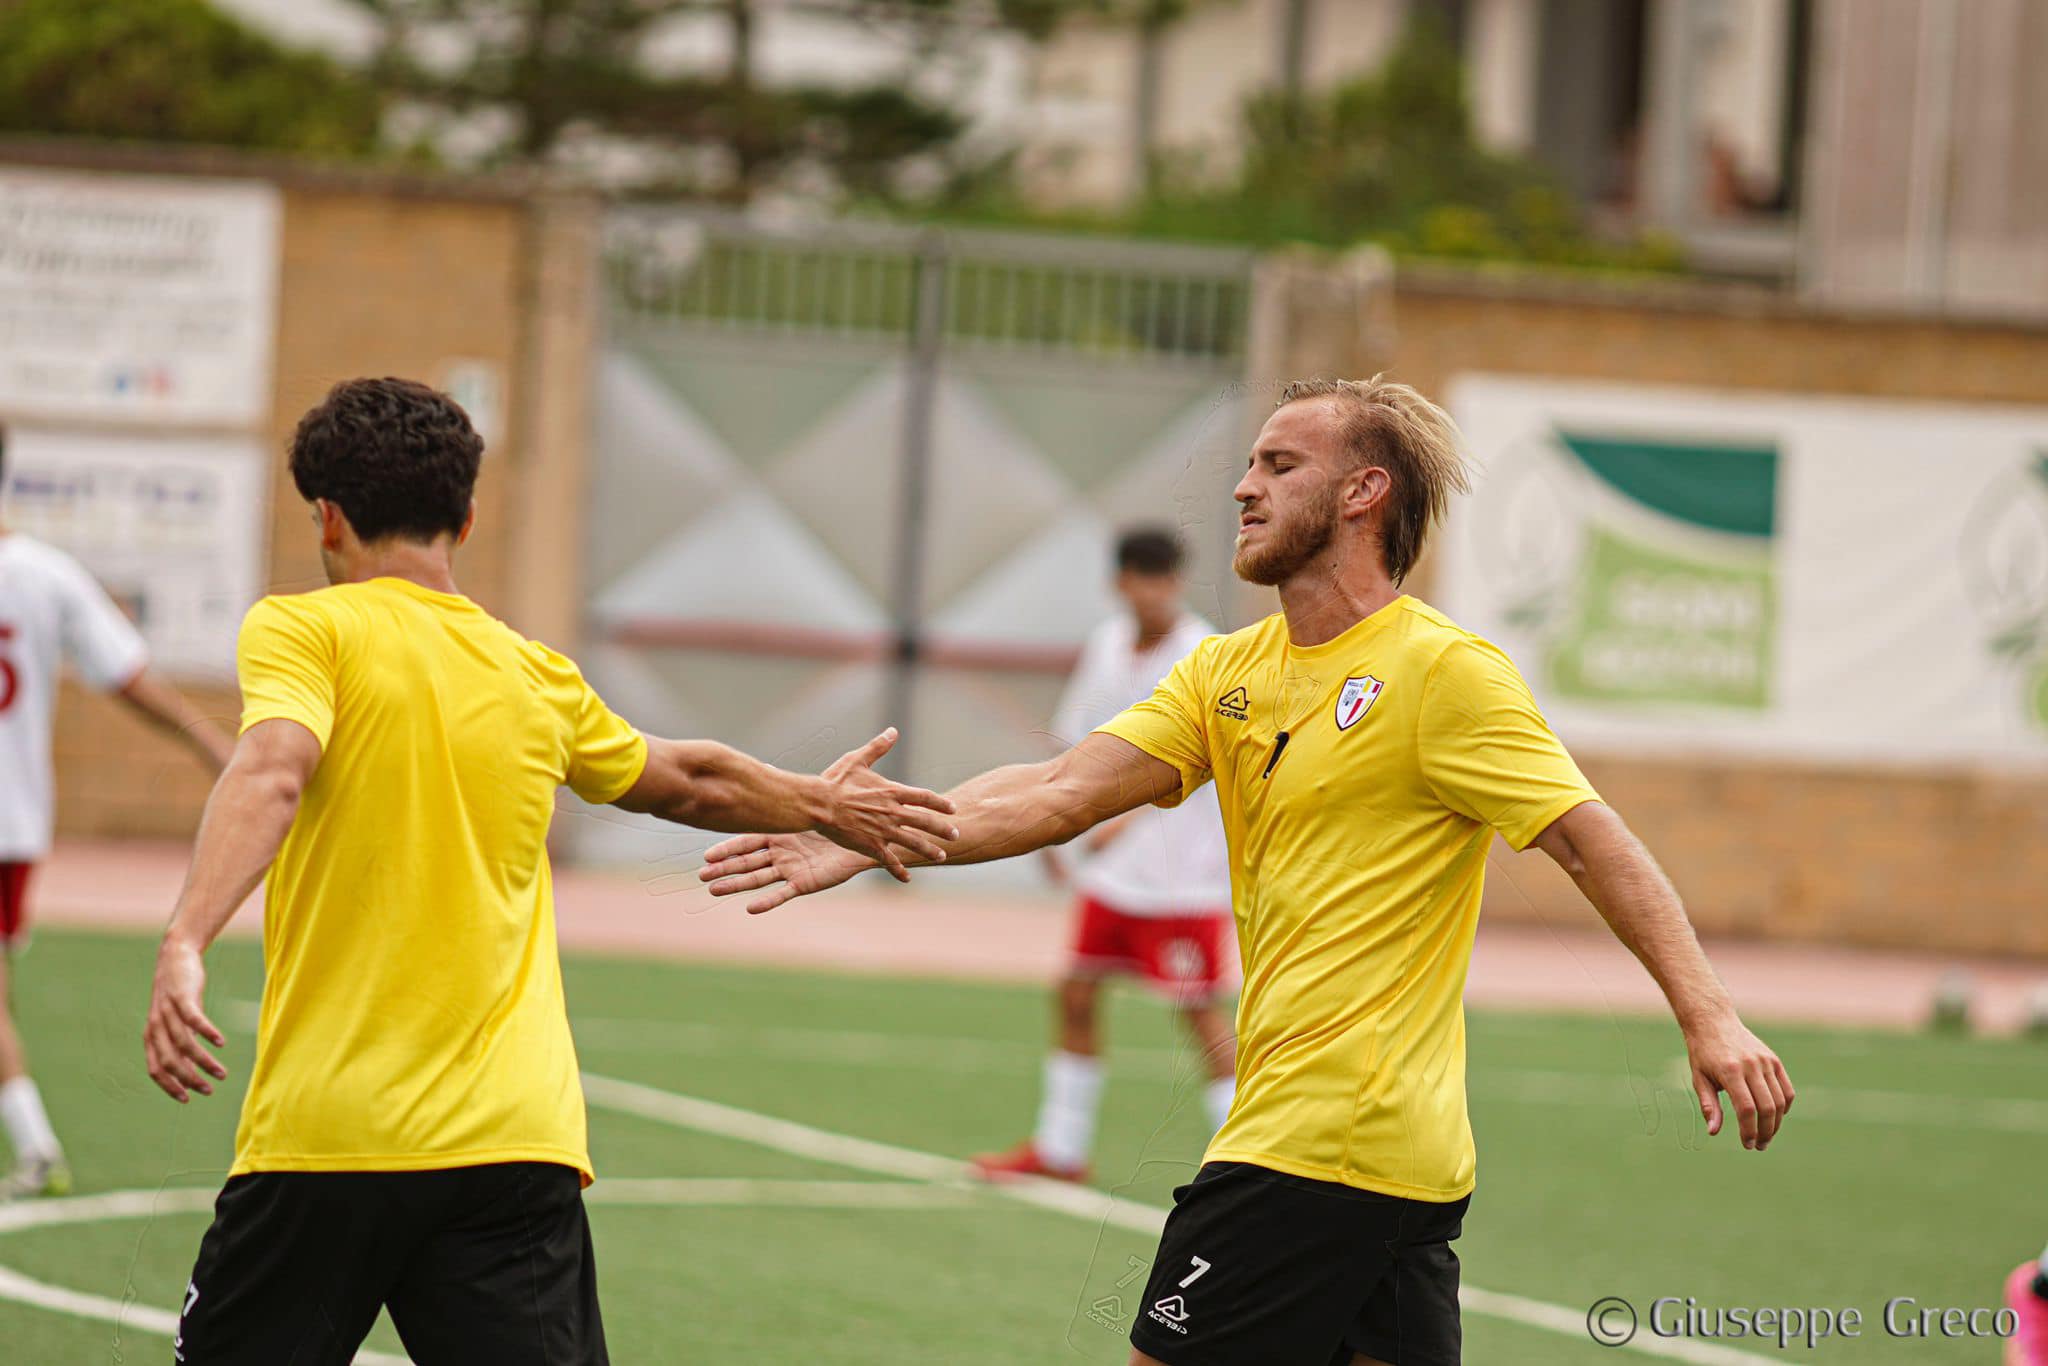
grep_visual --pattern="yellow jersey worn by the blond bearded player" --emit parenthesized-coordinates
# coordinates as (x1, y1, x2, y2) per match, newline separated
(1102, 598, 1597, 1200)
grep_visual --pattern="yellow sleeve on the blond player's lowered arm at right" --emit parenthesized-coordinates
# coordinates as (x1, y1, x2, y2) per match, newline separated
(1415, 639, 1599, 850)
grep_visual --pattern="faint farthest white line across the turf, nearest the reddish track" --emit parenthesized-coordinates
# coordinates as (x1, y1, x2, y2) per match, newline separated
(216, 1001, 2048, 1135)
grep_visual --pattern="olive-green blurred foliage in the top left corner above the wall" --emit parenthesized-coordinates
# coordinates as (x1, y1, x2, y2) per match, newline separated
(0, 0, 383, 156)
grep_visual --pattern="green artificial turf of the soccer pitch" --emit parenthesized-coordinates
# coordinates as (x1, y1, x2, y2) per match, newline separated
(0, 932, 2048, 1366)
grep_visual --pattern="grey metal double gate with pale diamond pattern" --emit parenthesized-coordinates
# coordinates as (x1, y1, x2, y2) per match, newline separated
(580, 209, 1251, 860)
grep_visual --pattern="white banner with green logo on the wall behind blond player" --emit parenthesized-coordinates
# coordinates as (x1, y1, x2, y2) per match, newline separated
(1436, 375, 2048, 768)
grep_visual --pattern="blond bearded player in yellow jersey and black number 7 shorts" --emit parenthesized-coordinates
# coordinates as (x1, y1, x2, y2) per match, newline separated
(702, 379, 1792, 1366)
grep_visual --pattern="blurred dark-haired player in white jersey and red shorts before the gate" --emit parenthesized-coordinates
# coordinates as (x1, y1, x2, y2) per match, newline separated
(975, 528, 1237, 1182)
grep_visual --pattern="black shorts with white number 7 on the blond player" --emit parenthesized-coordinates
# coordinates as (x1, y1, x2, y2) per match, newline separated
(1130, 1161, 1470, 1366)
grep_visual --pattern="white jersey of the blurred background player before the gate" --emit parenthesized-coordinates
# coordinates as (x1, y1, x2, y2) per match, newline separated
(1053, 612, 1231, 915)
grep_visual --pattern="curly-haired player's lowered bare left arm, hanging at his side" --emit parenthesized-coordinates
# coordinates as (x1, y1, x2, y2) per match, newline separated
(141, 721, 319, 1104)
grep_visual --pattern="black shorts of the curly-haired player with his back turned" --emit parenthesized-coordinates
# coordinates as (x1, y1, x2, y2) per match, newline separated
(176, 1161, 610, 1366)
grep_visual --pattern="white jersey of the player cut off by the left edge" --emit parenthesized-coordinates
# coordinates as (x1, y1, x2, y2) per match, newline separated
(0, 532, 150, 862)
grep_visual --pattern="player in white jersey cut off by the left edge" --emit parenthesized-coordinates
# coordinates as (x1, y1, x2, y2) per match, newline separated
(0, 428, 229, 1200)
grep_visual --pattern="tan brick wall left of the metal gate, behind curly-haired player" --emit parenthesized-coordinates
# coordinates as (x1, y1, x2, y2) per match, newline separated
(0, 143, 598, 838)
